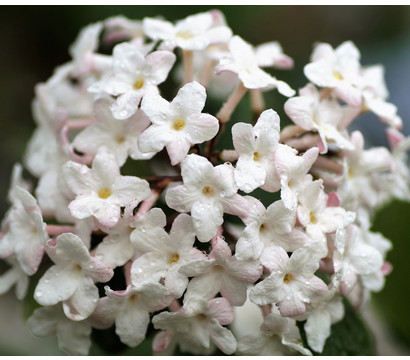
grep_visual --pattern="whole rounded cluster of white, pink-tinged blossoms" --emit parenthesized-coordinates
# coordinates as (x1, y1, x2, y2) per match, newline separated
(0, 10, 410, 355)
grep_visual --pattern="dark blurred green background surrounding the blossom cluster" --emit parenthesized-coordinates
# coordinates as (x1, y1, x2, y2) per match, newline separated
(0, 5, 410, 355)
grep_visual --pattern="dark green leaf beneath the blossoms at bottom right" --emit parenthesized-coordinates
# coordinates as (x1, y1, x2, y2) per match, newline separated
(297, 299, 374, 356)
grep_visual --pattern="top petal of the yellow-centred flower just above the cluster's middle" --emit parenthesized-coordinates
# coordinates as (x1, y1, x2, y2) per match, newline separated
(171, 81, 206, 118)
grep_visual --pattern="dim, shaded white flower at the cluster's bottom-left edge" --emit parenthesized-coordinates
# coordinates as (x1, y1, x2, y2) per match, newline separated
(27, 305, 91, 356)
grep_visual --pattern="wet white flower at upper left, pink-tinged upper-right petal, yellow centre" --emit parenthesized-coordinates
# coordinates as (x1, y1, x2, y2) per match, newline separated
(89, 42, 176, 120)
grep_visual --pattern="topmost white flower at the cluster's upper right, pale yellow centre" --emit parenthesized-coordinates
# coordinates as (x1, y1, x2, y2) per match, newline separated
(304, 41, 362, 107)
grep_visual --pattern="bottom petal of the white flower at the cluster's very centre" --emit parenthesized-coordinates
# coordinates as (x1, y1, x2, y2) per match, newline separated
(191, 201, 223, 242)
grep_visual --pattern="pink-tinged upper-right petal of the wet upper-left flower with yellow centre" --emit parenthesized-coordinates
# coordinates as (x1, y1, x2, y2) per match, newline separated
(144, 51, 176, 85)
